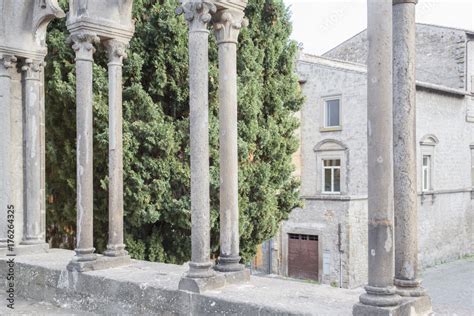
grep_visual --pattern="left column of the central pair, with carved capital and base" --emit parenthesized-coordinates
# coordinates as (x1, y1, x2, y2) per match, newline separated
(177, 0, 215, 278)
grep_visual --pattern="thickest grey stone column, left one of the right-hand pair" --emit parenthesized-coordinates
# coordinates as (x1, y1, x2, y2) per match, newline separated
(354, 0, 400, 314)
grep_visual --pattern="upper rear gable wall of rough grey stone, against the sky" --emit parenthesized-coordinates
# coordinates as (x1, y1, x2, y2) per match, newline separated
(323, 24, 466, 88)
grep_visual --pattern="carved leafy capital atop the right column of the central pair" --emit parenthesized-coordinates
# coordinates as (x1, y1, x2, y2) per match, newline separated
(212, 9, 248, 44)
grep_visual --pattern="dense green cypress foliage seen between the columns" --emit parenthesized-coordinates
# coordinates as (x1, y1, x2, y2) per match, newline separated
(45, 0, 302, 263)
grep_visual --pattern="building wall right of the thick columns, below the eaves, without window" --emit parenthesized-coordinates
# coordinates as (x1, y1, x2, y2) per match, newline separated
(417, 90, 474, 267)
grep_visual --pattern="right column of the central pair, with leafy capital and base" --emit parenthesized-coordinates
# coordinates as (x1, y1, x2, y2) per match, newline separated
(213, 9, 244, 272)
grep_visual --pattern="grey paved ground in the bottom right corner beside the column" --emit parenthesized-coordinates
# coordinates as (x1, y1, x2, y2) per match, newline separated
(422, 258, 474, 316)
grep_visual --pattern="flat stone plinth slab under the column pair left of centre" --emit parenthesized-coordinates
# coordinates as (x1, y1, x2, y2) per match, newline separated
(67, 254, 132, 272)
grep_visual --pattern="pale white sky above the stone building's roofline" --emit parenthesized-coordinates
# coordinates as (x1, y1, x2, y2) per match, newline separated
(284, 0, 474, 55)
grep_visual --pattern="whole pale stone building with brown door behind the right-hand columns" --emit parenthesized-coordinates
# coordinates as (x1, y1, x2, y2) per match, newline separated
(260, 24, 474, 288)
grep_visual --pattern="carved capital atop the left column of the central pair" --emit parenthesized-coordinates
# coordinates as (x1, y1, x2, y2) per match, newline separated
(176, 0, 216, 32)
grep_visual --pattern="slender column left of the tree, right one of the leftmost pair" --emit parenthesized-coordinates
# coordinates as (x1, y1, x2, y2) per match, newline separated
(21, 59, 45, 245)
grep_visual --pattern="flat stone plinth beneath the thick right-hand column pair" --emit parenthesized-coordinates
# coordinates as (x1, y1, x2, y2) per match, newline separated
(352, 296, 433, 316)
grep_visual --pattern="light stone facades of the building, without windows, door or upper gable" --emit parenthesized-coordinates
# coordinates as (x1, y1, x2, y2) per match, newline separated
(280, 49, 474, 287)
